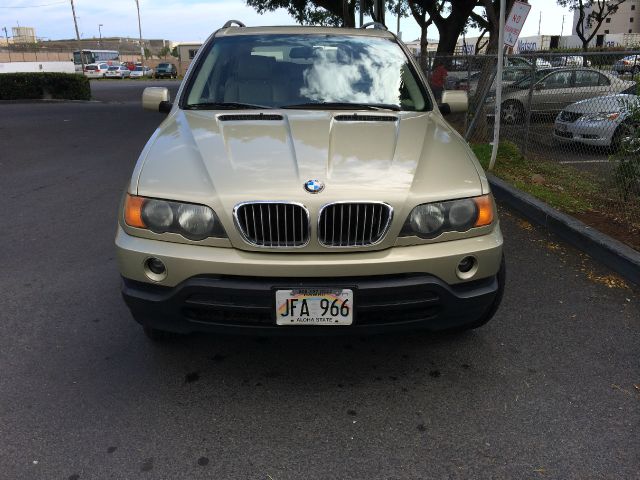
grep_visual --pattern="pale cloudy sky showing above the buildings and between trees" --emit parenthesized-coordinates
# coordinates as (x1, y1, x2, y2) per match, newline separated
(0, 0, 573, 41)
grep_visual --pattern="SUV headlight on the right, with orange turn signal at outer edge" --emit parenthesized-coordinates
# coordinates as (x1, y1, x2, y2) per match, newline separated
(401, 195, 494, 238)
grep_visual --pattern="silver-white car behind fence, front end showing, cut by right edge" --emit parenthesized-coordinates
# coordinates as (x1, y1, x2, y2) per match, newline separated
(553, 94, 640, 153)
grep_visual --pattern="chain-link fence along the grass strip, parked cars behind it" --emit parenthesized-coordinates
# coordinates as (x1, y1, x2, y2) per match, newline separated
(427, 51, 640, 249)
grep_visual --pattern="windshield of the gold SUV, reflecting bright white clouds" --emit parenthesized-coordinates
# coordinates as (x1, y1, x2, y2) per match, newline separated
(182, 35, 431, 111)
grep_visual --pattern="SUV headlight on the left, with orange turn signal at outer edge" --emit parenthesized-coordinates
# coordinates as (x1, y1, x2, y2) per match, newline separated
(124, 194, 227, 240)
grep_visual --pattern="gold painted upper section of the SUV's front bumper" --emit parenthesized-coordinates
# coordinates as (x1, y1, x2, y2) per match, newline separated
(115, 224, 503, 287)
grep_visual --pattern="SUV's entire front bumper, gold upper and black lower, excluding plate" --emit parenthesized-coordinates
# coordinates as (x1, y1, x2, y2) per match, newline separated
(116, 225, 504, 335)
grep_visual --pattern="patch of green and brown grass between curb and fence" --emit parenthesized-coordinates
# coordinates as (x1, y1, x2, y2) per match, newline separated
(472, 142, 604, 213)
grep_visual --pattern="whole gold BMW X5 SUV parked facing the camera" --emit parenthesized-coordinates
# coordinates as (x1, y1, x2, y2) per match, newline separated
(115, 21, 504, 339)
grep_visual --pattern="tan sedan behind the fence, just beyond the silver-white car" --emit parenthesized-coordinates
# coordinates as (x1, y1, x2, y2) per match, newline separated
(488, 68, 636, 123)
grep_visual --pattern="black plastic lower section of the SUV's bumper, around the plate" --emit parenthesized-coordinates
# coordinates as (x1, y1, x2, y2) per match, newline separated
(122, 270, 504, 335)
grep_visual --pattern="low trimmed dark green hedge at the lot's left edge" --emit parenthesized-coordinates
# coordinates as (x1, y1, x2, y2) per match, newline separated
(0, 73, 91, 100)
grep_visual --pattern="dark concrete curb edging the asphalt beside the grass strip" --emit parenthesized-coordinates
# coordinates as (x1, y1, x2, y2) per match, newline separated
(487, 174, 640, 285)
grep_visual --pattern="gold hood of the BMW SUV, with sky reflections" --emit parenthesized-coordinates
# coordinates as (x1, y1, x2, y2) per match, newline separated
(130, 109, 488, 251)
